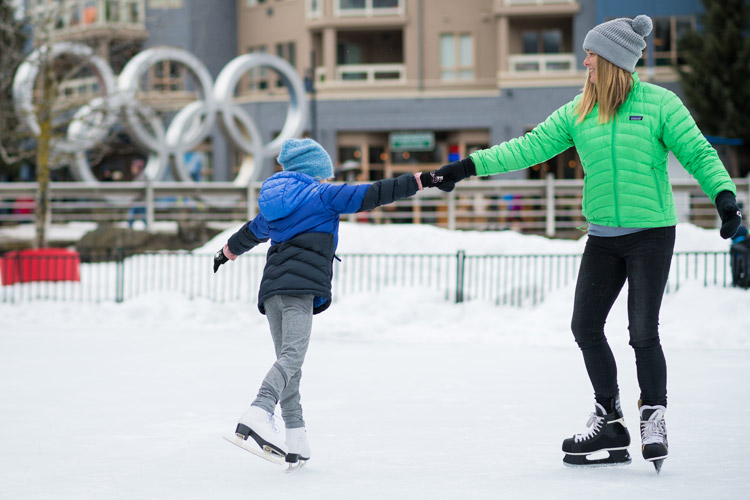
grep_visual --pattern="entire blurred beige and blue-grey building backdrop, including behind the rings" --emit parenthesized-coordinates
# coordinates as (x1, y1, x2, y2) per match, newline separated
(27, 0, 702, 181)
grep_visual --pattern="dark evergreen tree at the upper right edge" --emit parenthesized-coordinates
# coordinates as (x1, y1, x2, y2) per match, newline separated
(678, 0, 750, 176)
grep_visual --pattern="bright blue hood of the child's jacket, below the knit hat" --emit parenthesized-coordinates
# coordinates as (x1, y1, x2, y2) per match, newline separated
(258, 171, 320, 221)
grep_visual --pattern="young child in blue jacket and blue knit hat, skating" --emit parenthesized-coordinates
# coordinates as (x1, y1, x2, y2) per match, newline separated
(214, 139, 454, 466)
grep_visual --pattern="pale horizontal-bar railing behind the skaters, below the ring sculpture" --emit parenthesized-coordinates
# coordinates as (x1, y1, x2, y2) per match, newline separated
(0, 175, 750, 236)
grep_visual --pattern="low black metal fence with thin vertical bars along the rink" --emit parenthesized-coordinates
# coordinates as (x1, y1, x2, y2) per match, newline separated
(0, 251, 731, 307)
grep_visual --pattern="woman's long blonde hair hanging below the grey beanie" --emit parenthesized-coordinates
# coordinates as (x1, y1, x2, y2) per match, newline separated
(575, 56, 633, 123)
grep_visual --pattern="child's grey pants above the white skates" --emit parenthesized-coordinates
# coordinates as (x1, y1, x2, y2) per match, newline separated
(252, 295, 314, 429)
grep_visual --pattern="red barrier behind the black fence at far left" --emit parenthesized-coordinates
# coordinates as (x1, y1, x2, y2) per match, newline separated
(0, 248, 81, 286)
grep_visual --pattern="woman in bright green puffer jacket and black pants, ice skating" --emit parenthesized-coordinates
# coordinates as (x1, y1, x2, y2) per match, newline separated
(434, 15, 741, 472)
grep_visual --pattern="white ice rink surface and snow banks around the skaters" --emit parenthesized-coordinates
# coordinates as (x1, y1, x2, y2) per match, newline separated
(0, 223, 750, 500)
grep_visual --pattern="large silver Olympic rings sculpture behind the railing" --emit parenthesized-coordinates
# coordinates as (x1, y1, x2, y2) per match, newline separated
(13, 42, 308, 186)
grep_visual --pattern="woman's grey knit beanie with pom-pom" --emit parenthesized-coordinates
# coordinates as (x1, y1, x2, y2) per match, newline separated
(583, 15, 653, 73)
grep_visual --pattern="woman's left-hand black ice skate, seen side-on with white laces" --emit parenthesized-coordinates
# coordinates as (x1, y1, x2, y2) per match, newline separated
(562, 397, 630, 467)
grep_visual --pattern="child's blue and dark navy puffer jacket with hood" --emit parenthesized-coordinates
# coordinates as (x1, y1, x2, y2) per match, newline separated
(228, 172, 418, 314)
